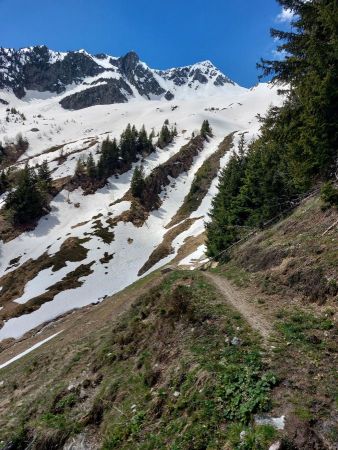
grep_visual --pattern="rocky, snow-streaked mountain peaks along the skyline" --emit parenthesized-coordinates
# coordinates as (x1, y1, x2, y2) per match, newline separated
(0, 46, 239, 109)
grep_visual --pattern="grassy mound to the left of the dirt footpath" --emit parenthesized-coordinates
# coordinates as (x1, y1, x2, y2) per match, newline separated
(1, 272, 276, 449)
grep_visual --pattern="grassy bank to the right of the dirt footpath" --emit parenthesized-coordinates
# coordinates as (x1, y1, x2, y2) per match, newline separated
(215, 197, 338, 449)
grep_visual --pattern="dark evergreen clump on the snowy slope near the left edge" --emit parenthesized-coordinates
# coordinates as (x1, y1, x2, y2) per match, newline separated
(4, 161, 52, 225)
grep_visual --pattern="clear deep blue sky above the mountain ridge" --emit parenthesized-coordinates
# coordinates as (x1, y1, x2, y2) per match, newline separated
(0, 0, 288, 87)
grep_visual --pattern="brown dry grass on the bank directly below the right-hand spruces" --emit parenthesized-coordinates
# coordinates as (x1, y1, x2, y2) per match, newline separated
(233, 198, 338, 303)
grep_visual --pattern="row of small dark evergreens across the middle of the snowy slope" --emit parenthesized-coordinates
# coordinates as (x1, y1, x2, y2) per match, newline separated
(75, 121, 177, 181)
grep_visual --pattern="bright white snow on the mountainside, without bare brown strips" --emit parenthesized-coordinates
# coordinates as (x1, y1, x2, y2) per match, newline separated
(0, 68, 281, 340)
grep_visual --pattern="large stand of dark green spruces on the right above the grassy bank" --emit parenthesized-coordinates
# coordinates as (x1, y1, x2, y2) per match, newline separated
(207, 0, 338, 257)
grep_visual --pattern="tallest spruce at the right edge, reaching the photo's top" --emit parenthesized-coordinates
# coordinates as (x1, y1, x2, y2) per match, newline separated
(258, 0, 338, 185)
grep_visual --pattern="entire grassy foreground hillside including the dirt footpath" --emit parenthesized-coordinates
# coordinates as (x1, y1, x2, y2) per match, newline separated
(0, 189, 337, 450)
